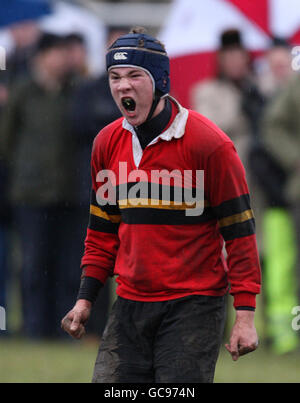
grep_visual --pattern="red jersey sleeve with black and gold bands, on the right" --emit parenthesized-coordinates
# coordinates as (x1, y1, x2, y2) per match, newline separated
(206, 142, 261, 307)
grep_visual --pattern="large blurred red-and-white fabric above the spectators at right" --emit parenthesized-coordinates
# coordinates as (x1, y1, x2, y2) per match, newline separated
(159, 0, 300, 107)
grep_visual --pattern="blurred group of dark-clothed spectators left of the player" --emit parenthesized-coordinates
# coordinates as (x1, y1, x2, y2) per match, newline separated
(0, 22, 120, 339)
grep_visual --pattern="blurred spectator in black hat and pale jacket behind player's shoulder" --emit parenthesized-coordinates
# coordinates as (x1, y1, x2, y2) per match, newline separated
(191, 29, 264, 248)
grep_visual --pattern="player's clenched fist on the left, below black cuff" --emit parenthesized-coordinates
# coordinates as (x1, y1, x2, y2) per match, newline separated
(61, 299, 92, 340)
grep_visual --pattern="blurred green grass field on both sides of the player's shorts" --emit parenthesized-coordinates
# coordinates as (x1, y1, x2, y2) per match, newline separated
(0, 338, 300, 383)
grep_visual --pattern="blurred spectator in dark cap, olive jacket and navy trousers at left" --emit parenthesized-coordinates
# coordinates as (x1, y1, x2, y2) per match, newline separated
(0, 34, 82, 338)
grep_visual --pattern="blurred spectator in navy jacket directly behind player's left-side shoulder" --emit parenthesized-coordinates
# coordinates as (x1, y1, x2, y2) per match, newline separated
(71, 29, 124, 336)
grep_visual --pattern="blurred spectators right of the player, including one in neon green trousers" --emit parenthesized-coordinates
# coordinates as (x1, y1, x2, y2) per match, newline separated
(191, 29, 300, 354)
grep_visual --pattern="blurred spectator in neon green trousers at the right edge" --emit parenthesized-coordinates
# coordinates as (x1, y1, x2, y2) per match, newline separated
(261, 68, 300, 354)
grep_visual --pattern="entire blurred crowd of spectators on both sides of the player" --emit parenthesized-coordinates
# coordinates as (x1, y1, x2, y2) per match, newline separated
(0, 19, 300, 353)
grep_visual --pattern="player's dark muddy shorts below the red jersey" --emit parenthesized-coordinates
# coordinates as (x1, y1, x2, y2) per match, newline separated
(93, 295, 225, 383)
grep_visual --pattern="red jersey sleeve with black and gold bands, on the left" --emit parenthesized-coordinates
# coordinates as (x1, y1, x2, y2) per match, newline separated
(81, 132, 121, 283)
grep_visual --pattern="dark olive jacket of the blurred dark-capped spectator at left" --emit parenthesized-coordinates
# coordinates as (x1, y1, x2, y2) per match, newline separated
(0, 79, 75, 205)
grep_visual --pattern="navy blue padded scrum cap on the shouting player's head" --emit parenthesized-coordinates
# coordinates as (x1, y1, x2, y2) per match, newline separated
(106, 31, 170, 95)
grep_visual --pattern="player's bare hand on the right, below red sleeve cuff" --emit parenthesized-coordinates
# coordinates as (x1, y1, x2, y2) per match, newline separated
(225, 311, 258, 361)
